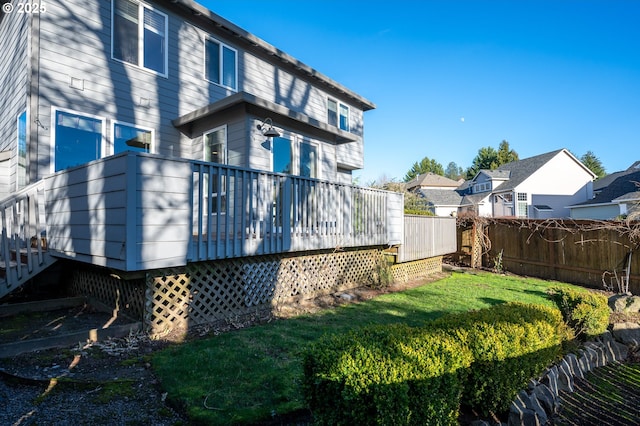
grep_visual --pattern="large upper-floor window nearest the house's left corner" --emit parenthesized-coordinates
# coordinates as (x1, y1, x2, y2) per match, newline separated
(111, 0, 168, 76)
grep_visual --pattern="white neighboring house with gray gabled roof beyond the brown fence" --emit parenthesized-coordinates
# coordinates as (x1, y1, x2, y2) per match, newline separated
(458, 149, 595, 219)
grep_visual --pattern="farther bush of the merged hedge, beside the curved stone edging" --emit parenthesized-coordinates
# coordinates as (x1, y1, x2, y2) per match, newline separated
(433, 303, 571, 415)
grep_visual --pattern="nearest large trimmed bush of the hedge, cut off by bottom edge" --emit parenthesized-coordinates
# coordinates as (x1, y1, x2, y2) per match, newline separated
(303, 325, 471, 425)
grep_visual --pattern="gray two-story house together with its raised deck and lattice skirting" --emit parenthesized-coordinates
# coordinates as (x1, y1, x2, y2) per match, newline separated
(0, 0, 455, 329)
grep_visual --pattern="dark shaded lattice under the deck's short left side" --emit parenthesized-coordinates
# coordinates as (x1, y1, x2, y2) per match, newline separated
(71, 270, 145, 321)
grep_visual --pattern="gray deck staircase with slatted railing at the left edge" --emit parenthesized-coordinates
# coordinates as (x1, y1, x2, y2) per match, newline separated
(0, 181, 56, 300)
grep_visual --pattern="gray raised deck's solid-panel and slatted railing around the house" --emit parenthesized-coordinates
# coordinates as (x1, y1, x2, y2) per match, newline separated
(45, 152, 403, 271)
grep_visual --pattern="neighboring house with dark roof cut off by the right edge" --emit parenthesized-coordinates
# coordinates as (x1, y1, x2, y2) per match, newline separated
(569, 162, 640, 220)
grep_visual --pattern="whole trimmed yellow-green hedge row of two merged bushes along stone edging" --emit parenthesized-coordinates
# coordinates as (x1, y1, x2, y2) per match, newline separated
(303, 303, 567, 425)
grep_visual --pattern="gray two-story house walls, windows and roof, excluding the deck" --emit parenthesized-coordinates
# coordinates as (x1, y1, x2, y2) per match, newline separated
(0, 0, 375, 194)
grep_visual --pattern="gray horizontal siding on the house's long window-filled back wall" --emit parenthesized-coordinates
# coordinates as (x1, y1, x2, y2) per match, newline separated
(37, 0, 363, 179)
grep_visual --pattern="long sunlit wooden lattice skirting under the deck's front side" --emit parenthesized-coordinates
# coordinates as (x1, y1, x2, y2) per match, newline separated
(145, 250, 380, 333)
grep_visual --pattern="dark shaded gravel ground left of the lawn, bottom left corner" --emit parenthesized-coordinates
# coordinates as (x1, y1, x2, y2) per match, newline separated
(0, 337, 187, 426)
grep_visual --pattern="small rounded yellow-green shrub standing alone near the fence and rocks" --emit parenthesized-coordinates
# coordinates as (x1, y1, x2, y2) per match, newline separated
(549, 287, 610, 338)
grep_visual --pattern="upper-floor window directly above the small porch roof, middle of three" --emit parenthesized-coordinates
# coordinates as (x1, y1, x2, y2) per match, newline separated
(204, 37, 238, 90)
